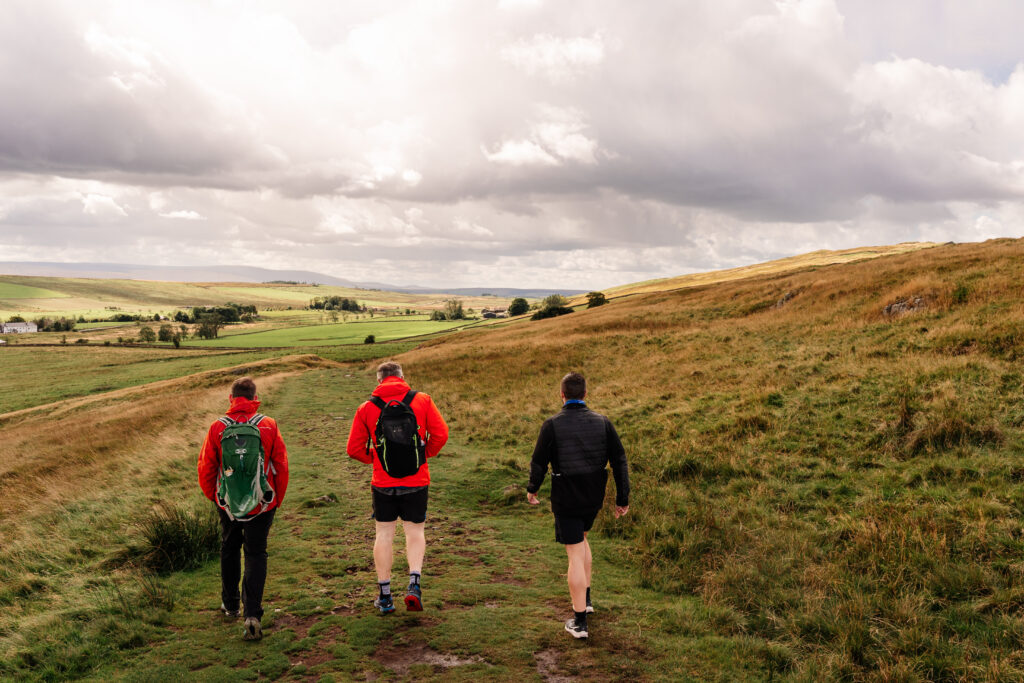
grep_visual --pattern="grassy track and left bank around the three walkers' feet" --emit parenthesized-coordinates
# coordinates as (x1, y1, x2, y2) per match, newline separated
(0, 356, 745, 681)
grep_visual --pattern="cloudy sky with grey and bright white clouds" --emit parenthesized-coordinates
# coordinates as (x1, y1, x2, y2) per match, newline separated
(0, 0, 1024, 289)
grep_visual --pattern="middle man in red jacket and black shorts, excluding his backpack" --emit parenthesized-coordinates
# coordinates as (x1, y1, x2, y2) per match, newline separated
(346, 360, 447, 614)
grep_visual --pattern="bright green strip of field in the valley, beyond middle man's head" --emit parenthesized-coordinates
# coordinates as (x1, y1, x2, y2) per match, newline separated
(185, 318, 483, 348)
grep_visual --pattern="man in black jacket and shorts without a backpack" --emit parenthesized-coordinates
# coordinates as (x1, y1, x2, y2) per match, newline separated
(526, 373, 630, 638)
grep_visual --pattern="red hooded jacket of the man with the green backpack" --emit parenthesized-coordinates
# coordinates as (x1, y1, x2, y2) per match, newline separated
(199, 396, 288, 516)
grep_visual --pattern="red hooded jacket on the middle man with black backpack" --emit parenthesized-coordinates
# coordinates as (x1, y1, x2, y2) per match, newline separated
(346, 377, 447, 487)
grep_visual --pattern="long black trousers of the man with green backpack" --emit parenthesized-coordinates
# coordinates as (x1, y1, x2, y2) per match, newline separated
(217, 508, 278, 618)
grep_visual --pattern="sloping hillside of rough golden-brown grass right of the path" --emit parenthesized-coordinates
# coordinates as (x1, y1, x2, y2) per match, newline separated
(403, 240, 1024, 680)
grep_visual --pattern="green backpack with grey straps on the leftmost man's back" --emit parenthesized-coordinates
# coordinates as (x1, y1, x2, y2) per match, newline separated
(217, 413, 274, 521)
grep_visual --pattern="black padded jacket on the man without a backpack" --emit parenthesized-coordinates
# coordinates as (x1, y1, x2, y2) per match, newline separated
(526, 403, 630, 516)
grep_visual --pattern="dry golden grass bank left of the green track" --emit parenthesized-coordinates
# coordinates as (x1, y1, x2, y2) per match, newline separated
(0, 355, 338, 536)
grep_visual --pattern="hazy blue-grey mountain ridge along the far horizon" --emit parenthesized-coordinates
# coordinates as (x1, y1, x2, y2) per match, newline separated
(0, 261, 586, 298)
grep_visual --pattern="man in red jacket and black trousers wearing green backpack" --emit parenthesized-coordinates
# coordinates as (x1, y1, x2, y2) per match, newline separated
(199, 377, 288, 640)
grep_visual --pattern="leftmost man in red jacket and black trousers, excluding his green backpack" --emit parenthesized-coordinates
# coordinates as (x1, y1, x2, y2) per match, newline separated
(199, 377, 288, 640)
